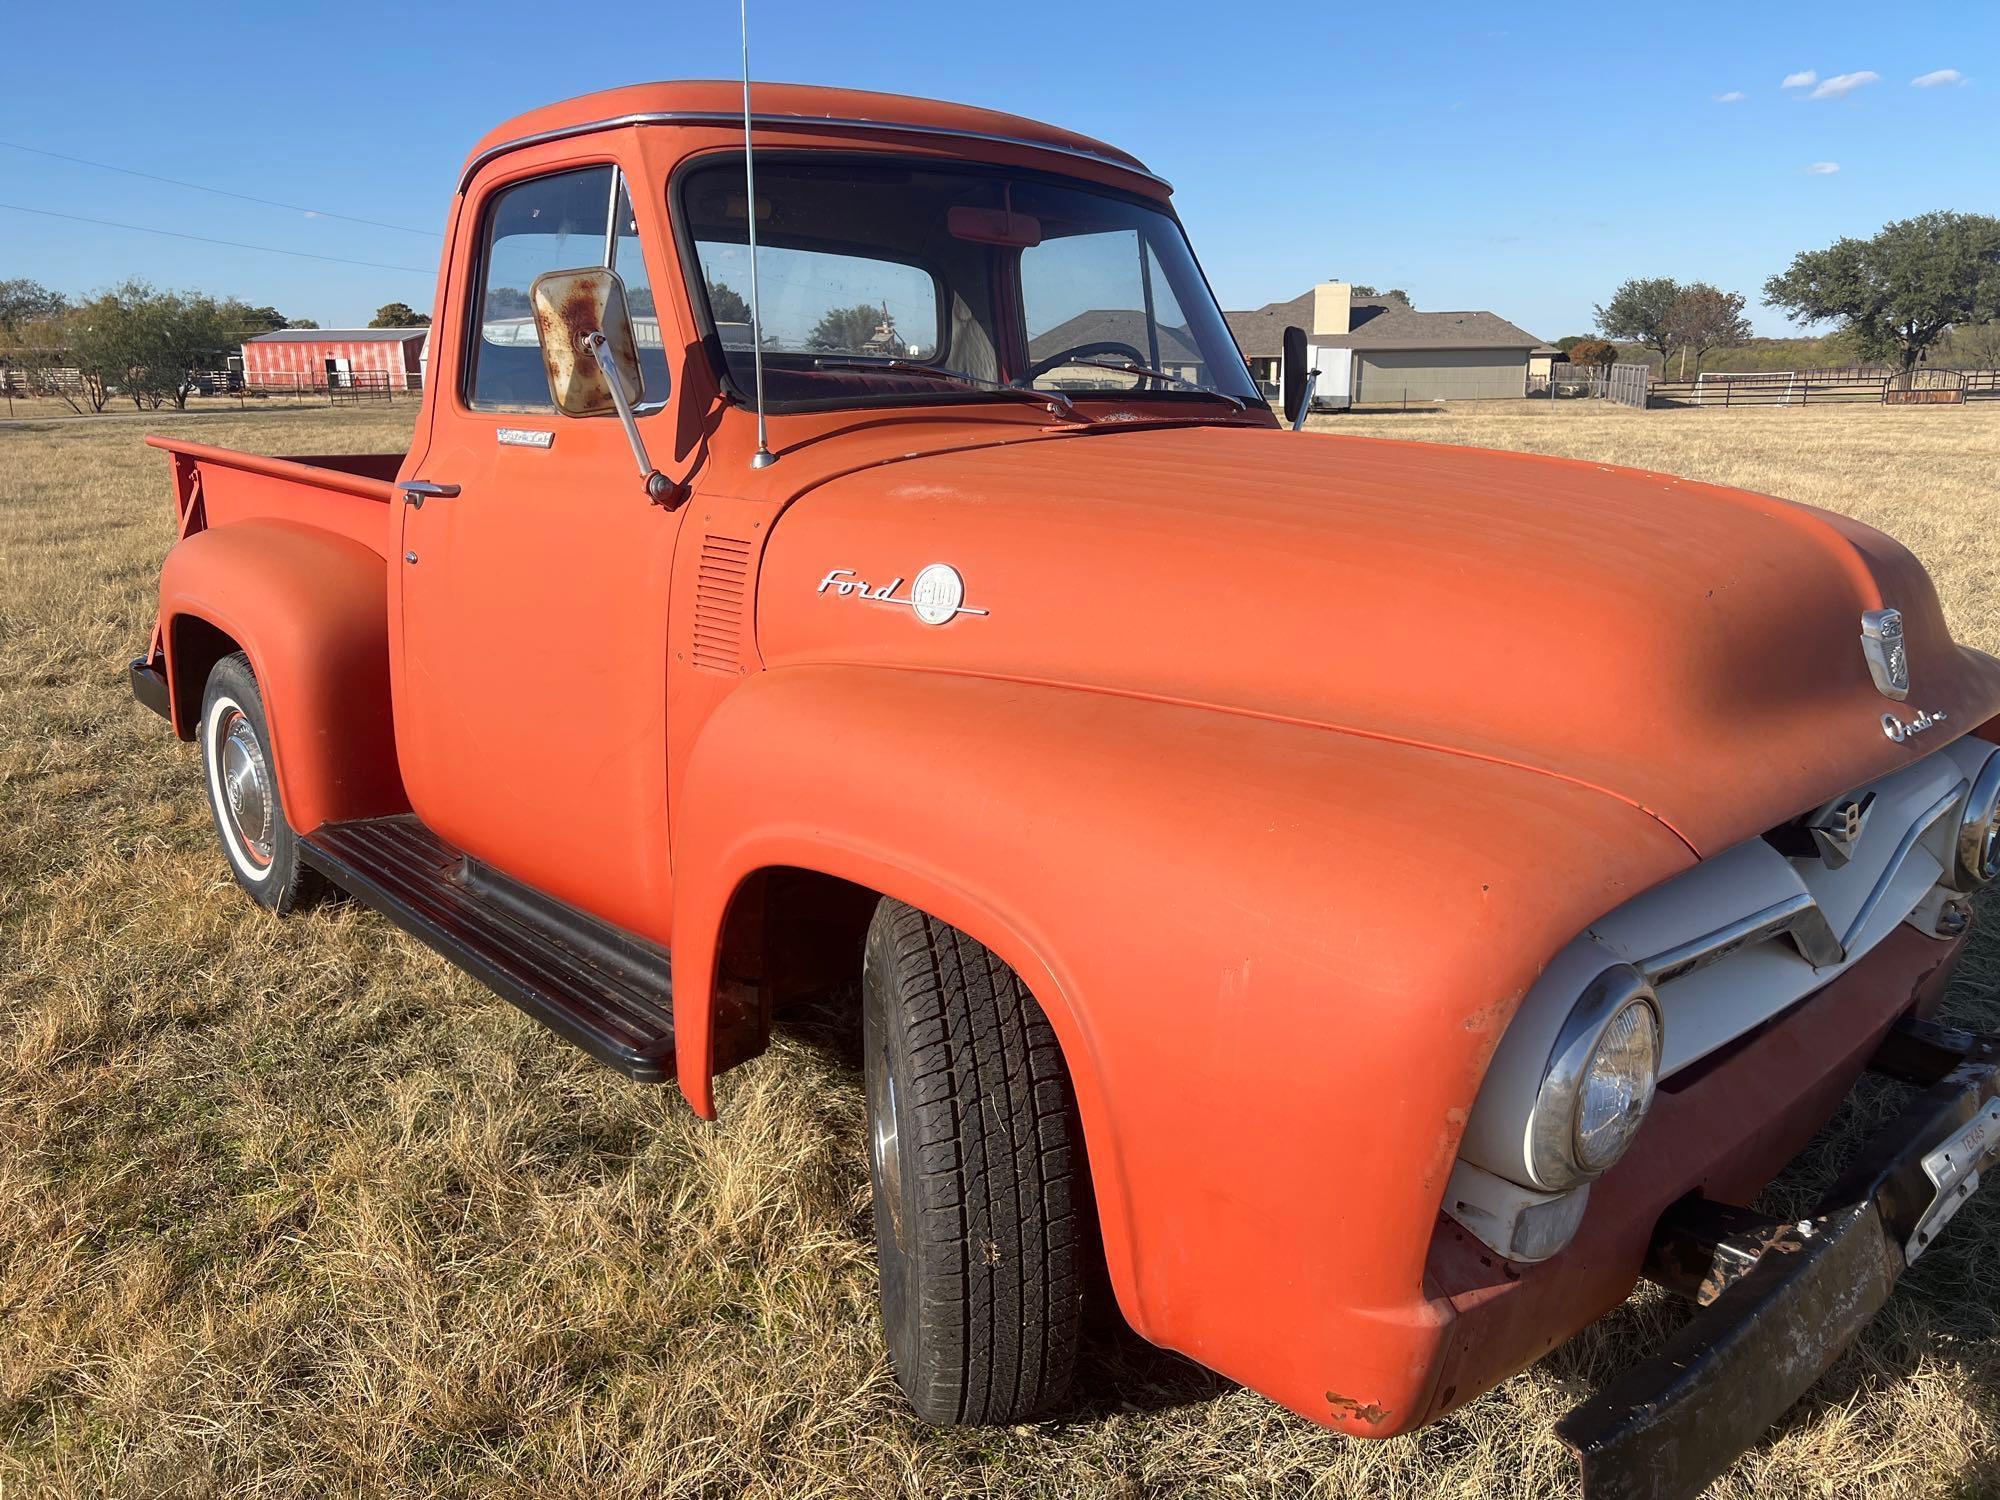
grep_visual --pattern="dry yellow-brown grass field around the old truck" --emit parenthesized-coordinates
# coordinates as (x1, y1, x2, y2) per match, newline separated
(0, 394, 2000, 1500)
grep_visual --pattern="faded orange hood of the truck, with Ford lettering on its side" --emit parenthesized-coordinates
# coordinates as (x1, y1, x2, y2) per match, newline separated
(756, 428, 2000, 854)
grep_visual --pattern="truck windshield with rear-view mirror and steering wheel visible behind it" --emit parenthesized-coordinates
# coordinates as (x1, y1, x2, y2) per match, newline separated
(680, 152, 1262, 414)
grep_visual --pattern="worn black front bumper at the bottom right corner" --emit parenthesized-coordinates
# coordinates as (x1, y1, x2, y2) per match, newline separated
(1556, 1020, 2000, 1500)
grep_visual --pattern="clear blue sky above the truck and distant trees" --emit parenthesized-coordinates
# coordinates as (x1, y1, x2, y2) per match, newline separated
(0, 0, 2000, 338)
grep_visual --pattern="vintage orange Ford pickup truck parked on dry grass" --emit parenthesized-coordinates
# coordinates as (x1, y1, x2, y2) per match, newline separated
(132, 84, 2000, 1494)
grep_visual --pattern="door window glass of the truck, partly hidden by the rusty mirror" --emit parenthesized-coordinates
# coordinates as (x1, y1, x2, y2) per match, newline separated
(466, 166, 612, 412)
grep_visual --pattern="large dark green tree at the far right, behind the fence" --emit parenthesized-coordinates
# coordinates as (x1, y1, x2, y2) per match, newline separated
(1764, 212, 2000, 386)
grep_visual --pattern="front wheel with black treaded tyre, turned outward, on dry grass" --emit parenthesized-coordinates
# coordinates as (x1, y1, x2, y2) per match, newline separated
(862, 900, 1090, 1426)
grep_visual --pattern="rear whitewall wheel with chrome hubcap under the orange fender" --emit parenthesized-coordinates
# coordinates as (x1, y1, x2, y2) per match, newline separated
(198, 652, 318, 912)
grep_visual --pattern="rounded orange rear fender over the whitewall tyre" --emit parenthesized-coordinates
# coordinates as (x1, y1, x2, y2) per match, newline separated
(160, 520, 410, 832)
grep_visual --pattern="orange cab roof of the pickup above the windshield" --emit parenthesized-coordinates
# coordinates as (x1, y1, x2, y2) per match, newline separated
(460, 78, 1168, 188)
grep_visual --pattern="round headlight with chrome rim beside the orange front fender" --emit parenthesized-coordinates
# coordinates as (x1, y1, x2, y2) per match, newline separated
(1528, 966, 1660, 1192)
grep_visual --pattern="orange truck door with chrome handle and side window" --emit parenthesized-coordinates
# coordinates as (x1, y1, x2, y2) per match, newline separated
(392, 158, 680, 942)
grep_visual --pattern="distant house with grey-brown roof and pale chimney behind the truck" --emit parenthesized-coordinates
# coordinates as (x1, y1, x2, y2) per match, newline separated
(1222, 282, 1546, 408)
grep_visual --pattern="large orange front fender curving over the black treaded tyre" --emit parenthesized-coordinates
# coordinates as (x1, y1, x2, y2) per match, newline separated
(674, 666, 1692, 1432)
